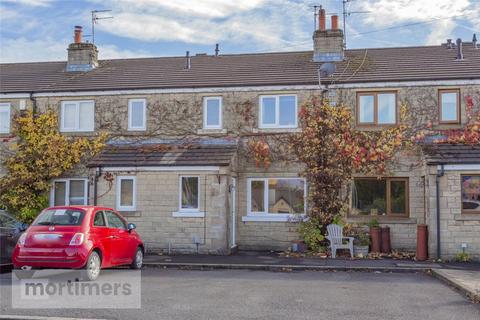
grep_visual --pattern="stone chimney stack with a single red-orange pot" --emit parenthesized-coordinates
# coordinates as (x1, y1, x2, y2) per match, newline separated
(66, 26, 98, 72)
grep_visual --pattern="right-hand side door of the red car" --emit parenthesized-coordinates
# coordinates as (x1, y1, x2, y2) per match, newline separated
(105, 211, 133, 265)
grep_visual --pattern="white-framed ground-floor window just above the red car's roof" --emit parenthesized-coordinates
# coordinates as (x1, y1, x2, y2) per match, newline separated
(50, 179, 88, 206)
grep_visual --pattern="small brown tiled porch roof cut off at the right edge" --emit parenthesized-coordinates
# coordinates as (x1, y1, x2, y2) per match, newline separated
(423, 144, 480, 164)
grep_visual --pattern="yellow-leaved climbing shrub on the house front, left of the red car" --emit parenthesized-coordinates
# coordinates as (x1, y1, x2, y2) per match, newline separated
(0, 110, 106, 222)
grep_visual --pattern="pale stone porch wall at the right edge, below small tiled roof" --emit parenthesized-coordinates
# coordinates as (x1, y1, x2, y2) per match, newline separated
(428, 166, 480, 260)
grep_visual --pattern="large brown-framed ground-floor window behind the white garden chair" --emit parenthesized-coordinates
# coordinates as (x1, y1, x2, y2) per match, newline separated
(352, 178, 408, 217)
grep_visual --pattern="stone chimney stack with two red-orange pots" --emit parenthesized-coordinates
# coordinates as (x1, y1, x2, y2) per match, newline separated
(313, 9, 344, 62)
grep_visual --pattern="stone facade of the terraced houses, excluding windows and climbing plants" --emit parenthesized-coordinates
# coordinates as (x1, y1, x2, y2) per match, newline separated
(0, 86, 480, 258)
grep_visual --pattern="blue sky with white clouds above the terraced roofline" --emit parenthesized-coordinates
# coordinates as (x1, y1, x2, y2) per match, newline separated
(0, 0, 480, 63)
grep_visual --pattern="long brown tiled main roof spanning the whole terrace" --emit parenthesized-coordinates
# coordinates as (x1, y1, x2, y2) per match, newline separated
(0, 43, 480, 93)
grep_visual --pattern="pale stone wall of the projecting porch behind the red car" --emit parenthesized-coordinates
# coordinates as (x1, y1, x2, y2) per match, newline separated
(90, 172, 230, 254)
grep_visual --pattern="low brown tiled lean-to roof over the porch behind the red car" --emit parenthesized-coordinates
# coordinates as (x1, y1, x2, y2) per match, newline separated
(87, 143, 237, 167)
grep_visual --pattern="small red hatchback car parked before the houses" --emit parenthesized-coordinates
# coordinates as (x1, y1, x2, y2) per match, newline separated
(12, 206, 145, 280)
